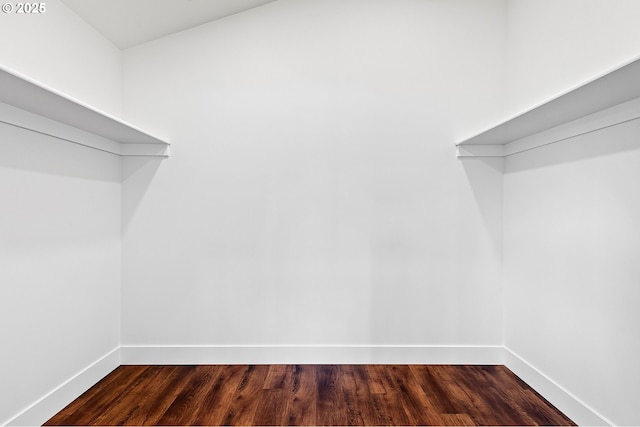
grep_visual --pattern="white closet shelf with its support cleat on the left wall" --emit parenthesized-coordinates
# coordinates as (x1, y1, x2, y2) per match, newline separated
(0, 65, 169, 158)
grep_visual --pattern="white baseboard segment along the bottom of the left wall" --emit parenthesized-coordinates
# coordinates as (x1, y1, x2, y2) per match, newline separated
(3, 347, 121, 426)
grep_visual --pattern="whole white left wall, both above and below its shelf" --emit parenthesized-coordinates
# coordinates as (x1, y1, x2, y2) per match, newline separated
(0, 1, 122, 424)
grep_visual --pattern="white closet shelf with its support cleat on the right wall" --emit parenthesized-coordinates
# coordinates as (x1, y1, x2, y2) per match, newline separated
(456, 56, 640, 157)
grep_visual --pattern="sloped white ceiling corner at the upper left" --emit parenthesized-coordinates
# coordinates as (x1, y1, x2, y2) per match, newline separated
(62, 0, 276, 49)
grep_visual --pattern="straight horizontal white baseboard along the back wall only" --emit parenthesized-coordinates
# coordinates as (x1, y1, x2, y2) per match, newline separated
(121, 345, 504, 365)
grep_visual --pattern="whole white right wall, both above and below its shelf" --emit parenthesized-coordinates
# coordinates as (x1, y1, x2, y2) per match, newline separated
(504, 0, 640, 425)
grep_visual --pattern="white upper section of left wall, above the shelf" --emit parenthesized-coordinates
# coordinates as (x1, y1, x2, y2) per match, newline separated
(0, 0, 122, 117)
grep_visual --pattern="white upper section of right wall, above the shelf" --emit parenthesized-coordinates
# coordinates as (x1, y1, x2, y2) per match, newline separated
(505, 0, 640, 114)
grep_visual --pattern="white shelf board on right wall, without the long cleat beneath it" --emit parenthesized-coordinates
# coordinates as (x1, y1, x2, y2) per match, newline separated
(456, 56, 640, 157)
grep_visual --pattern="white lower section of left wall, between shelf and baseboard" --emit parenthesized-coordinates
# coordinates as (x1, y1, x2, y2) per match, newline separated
(0, 124, 121, 424)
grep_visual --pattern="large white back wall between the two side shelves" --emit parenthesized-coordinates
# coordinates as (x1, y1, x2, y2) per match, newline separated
(122, 0, 504, 345)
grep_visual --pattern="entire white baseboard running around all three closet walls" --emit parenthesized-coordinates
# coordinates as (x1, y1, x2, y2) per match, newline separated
(7, 345, 613, 426)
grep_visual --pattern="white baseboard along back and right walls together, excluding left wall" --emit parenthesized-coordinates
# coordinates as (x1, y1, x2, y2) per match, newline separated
(121, 345, 613, 426)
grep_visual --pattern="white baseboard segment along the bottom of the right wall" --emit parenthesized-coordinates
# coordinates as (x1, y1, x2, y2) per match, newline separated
(504, 347, 614, 426)
